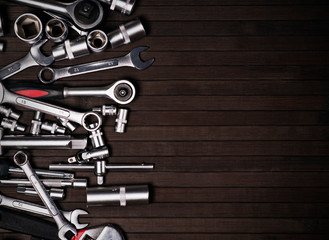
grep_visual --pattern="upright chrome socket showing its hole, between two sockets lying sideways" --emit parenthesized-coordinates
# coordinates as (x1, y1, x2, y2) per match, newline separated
(87, 30, 109, 53)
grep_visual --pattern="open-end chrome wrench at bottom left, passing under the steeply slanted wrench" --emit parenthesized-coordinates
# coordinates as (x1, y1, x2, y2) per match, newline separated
(0, 194, 88, 229)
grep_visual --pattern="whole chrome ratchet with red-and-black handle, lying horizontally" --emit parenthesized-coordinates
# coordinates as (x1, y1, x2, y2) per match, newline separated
(5, 80, 136, 105)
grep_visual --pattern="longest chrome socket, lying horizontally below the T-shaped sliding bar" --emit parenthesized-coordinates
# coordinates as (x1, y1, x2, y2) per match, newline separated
(87, 185, 149, 207)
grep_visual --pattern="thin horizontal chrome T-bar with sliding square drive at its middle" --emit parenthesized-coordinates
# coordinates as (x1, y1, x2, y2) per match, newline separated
(49, 160, 154, 187)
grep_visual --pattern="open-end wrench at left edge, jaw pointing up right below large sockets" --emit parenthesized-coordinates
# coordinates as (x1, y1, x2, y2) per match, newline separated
(0, 39, 55, 79)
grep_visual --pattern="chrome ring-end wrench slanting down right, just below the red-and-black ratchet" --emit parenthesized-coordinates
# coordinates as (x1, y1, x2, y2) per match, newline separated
(0, 82, 102, 131)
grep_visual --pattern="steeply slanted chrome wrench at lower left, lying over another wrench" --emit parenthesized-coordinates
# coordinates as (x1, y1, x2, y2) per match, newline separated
(13, 151, 77, 240)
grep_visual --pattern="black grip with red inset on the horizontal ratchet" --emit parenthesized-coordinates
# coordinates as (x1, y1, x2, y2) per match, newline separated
(4, 81, 64, 100)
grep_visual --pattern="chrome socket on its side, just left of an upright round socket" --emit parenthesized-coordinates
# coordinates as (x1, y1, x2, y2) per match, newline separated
(52, 37, 90, 61)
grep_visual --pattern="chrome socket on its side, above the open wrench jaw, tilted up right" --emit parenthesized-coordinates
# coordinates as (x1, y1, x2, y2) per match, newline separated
(107, 19, 146, 48)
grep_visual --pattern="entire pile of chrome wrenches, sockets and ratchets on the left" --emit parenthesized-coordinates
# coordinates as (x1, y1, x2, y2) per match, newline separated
(0, 0, 154, 240)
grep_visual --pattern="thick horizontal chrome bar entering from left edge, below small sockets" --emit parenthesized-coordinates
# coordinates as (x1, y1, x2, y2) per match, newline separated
(0, 128, 87, 155)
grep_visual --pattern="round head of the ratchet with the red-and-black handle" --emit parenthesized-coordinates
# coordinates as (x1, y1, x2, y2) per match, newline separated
(106, 80, 136, 104)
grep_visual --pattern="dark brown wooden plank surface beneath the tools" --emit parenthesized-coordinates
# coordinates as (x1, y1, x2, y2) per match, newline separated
(0, 0, 329, 240)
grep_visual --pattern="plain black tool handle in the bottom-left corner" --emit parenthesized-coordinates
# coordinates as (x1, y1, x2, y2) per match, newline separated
(0, 207, 59, 240)
